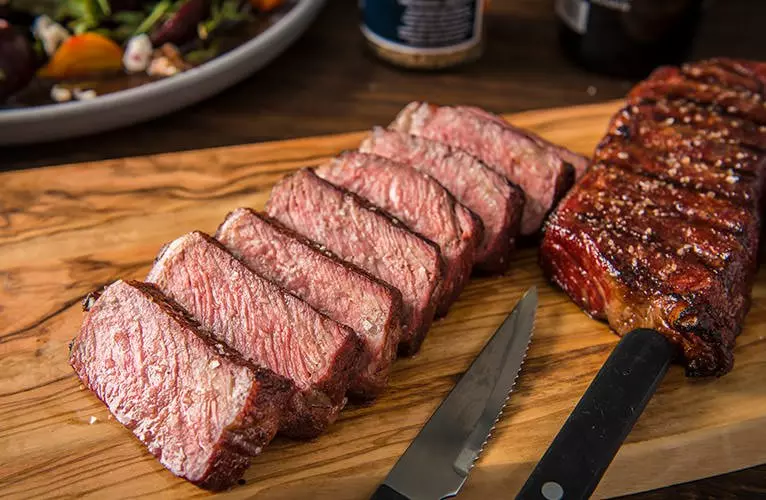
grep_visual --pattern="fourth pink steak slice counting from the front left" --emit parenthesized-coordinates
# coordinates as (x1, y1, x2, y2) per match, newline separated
(267, 169, 443, 354)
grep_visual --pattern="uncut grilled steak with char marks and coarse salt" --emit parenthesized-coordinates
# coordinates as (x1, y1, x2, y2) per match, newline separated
(541, 62, 766, 376)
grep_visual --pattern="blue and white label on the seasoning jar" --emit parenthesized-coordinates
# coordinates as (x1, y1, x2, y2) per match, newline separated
(360, 0, 483, 54)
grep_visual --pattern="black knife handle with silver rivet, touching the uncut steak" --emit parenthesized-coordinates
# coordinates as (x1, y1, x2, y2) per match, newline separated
(516, 329, 677, 500)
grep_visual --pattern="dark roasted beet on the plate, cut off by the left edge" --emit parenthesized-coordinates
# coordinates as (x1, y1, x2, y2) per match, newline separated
(0, 19, 36, 102)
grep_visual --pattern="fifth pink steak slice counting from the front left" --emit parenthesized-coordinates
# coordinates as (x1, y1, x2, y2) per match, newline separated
(316, 151, 483, 316)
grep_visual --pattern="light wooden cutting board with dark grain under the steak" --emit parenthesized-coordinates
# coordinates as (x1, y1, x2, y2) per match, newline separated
(0, 103, 766, 499)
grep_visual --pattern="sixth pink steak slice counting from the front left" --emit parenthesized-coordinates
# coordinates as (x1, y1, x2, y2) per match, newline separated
(359, 127, 524, 272)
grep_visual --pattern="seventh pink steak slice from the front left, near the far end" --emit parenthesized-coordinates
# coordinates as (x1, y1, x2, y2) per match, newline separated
(390, 102, 575, 235)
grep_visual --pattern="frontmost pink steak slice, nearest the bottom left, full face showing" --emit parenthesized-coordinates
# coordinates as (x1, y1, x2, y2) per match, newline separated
(69, 281, 294, 490)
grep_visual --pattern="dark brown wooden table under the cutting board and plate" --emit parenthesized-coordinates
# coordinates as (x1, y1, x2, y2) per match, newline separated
(6, 0, 766, 499)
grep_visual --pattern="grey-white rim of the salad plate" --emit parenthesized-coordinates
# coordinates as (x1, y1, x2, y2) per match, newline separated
(0, 0, 325, 145)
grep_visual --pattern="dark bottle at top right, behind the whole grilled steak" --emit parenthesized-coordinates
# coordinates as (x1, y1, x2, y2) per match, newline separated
(556, 0, 704, 78)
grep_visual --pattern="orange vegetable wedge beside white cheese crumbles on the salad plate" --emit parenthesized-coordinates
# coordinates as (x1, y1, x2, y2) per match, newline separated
(37, 33, 122, 79)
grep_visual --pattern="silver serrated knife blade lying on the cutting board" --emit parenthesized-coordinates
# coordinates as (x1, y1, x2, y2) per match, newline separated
(372, 287, 537, 500)
